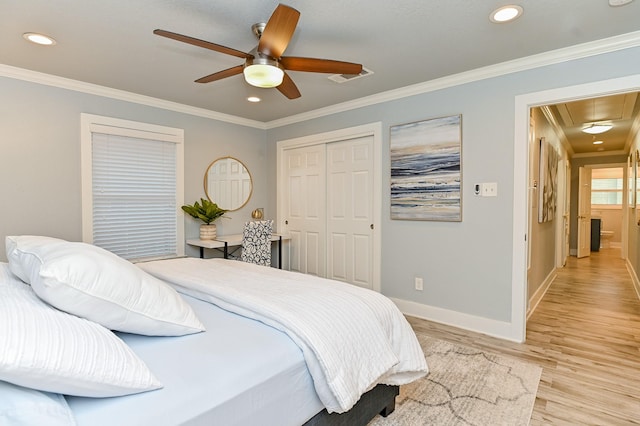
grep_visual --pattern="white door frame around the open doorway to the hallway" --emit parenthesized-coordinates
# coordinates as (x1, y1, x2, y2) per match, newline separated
(508, 74, 640, 342)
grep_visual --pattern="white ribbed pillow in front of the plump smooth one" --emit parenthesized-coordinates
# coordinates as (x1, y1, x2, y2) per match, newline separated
(0, 263, 162, 397)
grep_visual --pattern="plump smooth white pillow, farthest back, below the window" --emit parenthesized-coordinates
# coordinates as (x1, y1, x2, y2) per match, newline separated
(6, 235, 204, 336)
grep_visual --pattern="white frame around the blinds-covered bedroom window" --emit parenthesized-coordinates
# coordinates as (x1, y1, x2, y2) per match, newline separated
(80, 113, 185, 257)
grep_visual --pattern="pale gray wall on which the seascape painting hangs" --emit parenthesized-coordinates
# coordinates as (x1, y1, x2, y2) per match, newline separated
(268, 48, 640, 322)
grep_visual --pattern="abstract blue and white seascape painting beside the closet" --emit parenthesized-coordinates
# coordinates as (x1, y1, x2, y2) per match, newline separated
(390, 115, 462, 222)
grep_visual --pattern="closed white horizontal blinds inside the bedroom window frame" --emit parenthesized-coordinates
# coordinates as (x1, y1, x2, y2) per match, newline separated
(92, 133, 178, 260)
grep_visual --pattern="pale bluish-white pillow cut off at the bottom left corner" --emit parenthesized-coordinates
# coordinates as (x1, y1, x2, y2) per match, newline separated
(0, 381, 76, 426)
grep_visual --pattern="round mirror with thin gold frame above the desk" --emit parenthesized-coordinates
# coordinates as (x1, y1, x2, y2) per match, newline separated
(204, 157, 253, 211)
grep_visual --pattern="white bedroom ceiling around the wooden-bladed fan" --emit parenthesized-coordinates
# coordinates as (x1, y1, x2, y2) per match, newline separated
(0, 0, 640, 152)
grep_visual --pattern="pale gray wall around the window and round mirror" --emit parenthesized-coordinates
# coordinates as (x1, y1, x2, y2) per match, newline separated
(0, 78, 270, 261)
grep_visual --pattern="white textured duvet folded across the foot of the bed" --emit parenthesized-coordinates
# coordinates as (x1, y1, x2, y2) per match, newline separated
(138, 258, 428, 413)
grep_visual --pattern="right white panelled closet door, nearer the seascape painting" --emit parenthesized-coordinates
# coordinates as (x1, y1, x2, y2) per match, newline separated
(327, 136, 374, 289)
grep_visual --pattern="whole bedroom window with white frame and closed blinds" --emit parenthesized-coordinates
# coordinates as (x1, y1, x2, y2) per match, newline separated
(81, 114, 184, 261)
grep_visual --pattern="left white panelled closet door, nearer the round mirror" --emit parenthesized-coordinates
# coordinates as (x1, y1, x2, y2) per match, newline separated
(284, 145, 326, 277)
